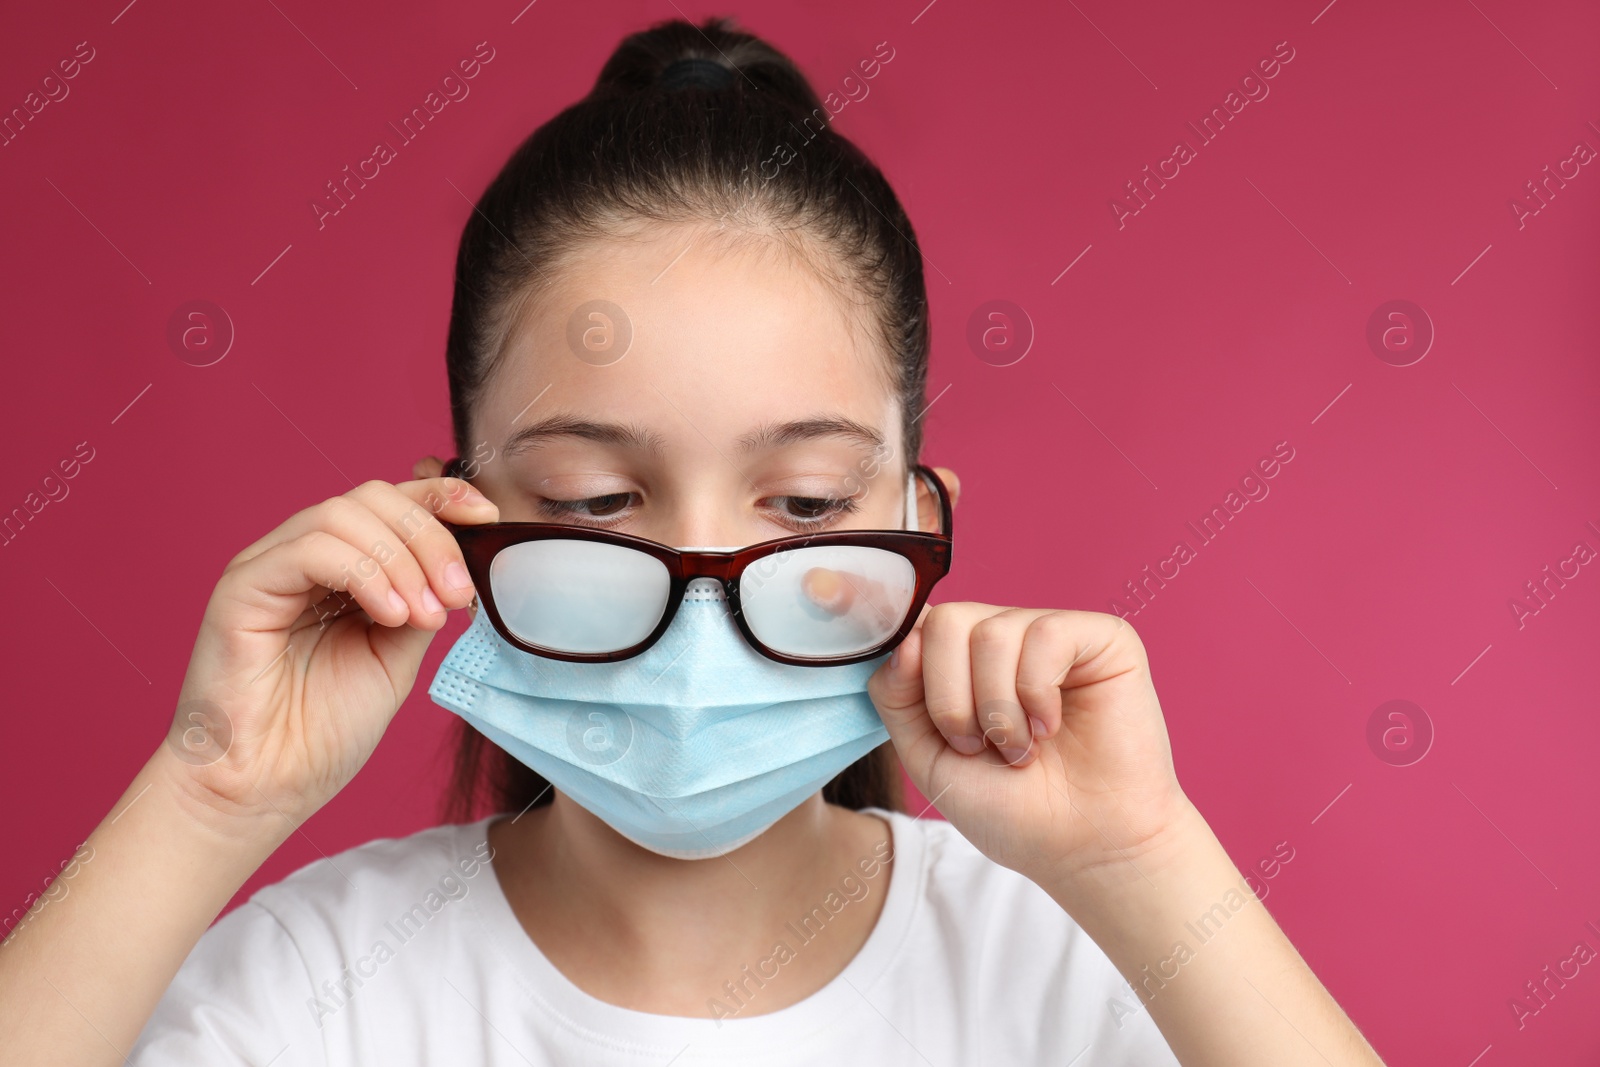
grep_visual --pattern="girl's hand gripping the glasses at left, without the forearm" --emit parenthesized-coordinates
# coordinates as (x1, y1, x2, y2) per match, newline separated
(163, 478, 499, 837)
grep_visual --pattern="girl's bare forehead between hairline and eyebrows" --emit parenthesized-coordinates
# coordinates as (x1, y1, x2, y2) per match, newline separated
(474, 224, 898, 450)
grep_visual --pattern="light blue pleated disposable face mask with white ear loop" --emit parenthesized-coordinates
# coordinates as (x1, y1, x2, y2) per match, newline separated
(427, 482, 915, 859)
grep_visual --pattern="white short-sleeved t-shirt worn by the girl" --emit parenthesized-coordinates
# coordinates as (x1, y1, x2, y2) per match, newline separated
(130, 808, 1178, 1067)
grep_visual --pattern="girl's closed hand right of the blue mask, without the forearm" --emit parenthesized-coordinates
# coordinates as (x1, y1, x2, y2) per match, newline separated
(867, 603, 1194, 891)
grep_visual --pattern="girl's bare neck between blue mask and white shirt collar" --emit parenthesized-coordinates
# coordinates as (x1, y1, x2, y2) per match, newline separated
(490, 792, 890, 1016)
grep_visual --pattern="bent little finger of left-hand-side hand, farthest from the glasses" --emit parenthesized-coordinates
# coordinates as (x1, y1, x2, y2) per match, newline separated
(214, 530, 411, 630)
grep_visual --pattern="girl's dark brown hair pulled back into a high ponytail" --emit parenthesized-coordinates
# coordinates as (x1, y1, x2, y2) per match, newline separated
(445, 18, 930, 821)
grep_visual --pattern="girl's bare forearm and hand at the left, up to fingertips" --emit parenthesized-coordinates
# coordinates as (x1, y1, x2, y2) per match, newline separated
(0, 478, 498, 1067)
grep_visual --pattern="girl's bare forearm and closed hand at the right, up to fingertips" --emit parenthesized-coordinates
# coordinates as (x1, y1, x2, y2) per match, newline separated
(869, 603, 1381, 1067)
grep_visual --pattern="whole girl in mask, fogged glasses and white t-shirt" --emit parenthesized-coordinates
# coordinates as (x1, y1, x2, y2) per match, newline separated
(0, 19, 1379, 1067)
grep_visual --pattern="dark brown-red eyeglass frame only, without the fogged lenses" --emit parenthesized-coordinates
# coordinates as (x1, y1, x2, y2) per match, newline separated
(440, 459, 954, 667)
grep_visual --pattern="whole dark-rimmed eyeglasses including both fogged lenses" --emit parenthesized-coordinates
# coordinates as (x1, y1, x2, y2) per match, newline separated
(443, 459, 952, 665)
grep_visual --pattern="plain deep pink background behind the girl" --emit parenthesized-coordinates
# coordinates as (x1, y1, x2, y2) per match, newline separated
(0, 0, 1600, 1067)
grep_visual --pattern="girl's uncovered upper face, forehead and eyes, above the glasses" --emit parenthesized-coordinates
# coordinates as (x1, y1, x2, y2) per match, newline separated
(467, 226, 928, 547)
